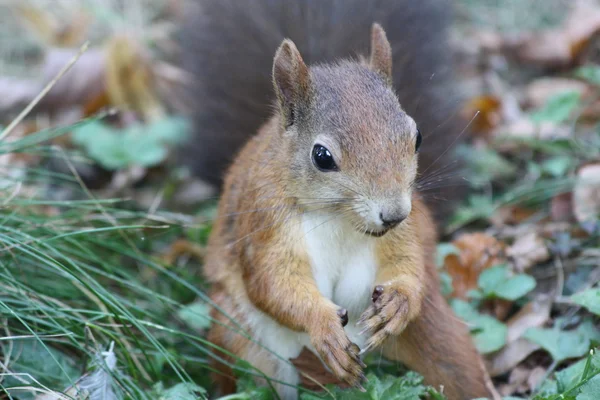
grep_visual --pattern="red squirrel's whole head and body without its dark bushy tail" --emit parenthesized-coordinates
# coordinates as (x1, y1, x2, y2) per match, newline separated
(196, 17, 493, 400)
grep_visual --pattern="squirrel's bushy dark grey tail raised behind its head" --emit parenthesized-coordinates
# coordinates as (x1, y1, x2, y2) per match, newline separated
(177, 0, 469, 220)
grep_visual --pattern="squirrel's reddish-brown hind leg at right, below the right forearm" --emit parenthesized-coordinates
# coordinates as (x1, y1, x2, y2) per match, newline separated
(382, 280, 495, 400)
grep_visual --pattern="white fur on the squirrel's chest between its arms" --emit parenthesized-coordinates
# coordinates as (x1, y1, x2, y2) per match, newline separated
(303, 213, 377, 336)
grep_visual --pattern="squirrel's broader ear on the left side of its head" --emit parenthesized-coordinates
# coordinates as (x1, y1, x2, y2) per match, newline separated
(273, 39, 310, 127)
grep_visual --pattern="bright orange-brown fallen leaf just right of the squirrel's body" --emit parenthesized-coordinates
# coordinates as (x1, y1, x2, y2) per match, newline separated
(444, 233, 504, 299)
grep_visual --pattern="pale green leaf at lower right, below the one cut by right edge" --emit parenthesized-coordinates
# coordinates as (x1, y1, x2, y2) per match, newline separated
(523, 321, 600, 361)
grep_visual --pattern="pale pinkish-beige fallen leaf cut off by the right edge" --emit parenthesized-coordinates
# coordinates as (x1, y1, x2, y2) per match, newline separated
(573, 163, 600, 223)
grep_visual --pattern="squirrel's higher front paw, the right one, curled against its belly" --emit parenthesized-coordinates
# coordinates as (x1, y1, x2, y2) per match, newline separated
(357, 285, 410, 354)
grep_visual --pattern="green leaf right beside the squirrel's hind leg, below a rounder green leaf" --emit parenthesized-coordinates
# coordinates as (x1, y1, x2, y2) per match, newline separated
(451, 299, 507, 354)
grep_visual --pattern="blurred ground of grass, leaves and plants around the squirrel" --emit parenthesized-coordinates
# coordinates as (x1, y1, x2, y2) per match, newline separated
(0, 0, 600, 400)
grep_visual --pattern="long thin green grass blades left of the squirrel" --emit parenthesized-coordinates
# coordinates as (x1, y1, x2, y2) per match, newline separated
(0, 119, 218, 398)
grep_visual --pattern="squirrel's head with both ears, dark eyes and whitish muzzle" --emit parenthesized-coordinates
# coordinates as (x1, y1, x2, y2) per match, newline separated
(273, 24, 421, 236)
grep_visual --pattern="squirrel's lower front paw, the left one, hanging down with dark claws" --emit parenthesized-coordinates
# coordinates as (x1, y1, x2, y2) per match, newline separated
(310, 310, 366, 389)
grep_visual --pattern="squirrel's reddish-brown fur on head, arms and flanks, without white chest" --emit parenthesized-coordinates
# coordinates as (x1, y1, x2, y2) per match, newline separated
(205, 27, 490, 400)
